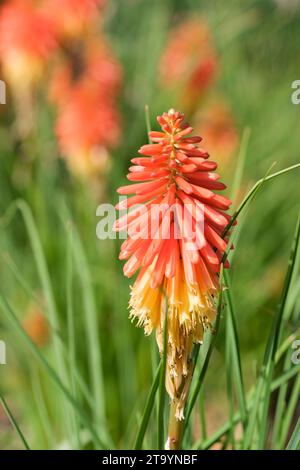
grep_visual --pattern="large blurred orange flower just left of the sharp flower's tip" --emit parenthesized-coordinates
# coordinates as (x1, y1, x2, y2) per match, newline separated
(50, 38, 121, 176)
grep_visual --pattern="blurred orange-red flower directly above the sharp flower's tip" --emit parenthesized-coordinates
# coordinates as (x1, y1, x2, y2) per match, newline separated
(160, 17, 218, 111)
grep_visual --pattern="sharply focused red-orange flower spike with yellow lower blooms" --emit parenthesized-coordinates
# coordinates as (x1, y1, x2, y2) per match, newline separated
(114, 110, 231, 420)
